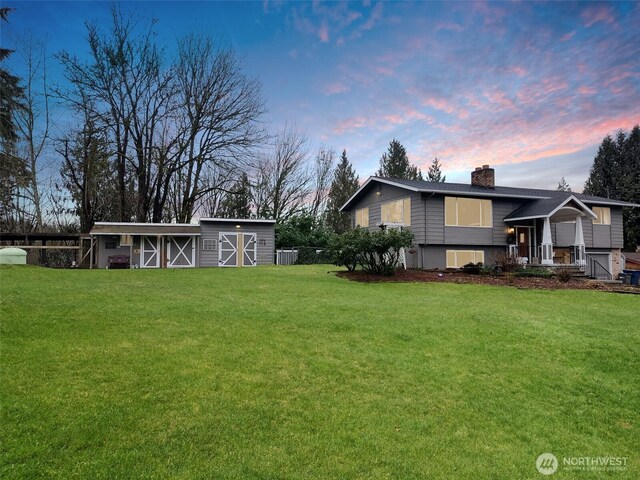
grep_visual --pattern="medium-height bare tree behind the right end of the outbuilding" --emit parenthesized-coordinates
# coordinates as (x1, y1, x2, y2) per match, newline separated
(256, 126, 312, 220)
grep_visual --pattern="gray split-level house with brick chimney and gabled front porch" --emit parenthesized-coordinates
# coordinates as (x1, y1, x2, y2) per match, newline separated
(342, 165, 640, 278)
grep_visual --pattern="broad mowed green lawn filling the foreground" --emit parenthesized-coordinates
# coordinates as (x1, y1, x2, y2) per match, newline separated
(0, 266, 640, 480)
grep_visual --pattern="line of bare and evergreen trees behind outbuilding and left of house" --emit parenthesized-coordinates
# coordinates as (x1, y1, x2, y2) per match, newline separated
(0, 5, 436, 239)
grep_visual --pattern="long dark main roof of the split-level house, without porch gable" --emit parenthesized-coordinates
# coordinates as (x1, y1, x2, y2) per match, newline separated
(340, 177, 640, 211)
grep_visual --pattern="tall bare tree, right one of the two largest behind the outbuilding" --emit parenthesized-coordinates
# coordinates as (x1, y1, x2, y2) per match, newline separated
(169, 36, 266, 221)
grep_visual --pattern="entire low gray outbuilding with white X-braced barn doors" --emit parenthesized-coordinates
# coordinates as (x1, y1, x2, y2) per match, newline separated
(89, 218, 275, 268)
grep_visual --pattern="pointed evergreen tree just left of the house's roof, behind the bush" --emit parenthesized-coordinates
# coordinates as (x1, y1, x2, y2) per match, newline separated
(326, 150, 359, 233)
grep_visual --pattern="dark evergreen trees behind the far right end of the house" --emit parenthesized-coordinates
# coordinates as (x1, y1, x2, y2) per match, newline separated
(584, 125, 640, 251)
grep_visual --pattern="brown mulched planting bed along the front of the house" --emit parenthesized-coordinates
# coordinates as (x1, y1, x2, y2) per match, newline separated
(336, 269, 640, 293)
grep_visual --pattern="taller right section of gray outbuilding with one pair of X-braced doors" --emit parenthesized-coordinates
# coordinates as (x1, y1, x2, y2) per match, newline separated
(200, 218, 276, 267)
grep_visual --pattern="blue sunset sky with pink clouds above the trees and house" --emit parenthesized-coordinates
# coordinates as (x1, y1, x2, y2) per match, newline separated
(1, 0, 640, 191)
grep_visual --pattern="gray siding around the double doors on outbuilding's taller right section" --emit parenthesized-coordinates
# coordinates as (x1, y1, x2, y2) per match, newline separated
(199, 220, 275, 267)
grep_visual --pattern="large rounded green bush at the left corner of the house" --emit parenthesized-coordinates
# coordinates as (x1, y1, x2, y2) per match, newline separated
(332, 228, 413, 275)
